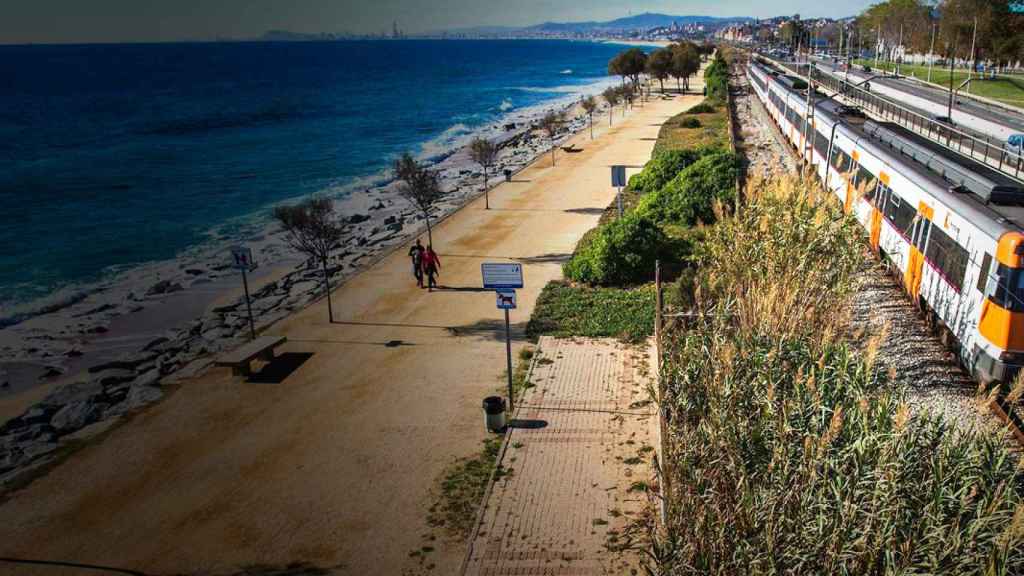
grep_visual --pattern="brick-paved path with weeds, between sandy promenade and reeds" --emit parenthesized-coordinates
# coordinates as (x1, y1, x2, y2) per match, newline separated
(465, 336, 657, 576)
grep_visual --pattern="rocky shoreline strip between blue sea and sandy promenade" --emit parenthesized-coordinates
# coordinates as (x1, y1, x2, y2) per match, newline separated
(0, 72, 611, 485)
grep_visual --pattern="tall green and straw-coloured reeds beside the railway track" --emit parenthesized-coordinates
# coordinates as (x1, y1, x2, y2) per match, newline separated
(648, 175, 1024, 575)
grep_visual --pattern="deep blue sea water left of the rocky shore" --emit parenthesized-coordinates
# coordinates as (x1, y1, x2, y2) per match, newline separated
(0, 40, 623, 311)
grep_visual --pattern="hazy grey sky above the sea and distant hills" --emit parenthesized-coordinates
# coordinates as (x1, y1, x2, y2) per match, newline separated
(0, 0, 871, 43)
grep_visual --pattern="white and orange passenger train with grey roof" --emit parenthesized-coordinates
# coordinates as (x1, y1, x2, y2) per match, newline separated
(745, 59, 1024, 385)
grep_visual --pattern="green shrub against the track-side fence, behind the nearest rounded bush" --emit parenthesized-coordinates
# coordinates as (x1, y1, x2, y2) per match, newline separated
(637, 151, 739, 225)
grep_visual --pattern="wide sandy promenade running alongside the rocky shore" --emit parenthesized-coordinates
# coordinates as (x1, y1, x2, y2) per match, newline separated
(0, 89, 700, 576)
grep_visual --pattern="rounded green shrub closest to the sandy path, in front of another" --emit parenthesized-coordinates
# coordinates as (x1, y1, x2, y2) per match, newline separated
(563, 212, 669, 286)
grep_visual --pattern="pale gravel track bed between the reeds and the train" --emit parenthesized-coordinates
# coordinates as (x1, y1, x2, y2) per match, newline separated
(730, 56, 1007, 438)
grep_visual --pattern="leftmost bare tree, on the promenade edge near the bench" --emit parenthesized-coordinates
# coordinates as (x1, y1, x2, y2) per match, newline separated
(273, 197, 345, 322)
